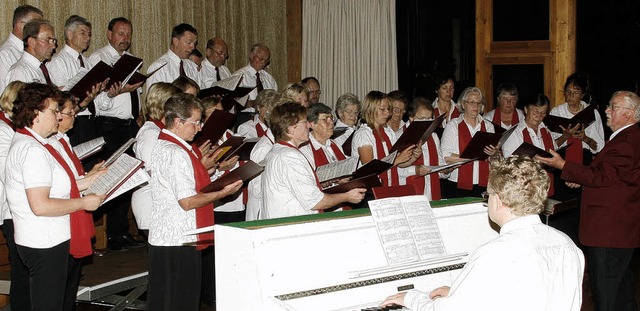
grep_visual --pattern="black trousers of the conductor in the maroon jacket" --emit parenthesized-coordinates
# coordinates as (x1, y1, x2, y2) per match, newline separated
(587, 247, 638, 311)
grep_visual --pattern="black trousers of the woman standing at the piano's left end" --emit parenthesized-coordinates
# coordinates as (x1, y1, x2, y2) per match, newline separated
(147, 245, 202, 311)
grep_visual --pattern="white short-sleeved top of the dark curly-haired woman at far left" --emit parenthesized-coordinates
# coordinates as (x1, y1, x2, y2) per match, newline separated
(5, 128, 71, 249)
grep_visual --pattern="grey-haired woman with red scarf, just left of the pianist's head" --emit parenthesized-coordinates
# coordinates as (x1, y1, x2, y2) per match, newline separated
(440, 87, 498, 198)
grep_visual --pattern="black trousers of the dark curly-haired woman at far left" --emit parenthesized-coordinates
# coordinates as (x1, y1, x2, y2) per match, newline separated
(17, 241, 69, 311)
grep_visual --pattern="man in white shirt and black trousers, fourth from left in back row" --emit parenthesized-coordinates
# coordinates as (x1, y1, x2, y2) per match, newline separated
(89, 17, 144, 250)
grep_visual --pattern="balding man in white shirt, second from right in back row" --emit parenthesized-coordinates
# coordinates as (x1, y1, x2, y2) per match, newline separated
(200, 37, 231, 88)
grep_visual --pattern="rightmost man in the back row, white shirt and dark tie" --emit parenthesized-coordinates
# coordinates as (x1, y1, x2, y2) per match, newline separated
(233, 43, 278, 102)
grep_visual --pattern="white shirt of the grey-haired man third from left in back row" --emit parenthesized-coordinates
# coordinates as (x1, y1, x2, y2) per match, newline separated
(47, 44, 93, 116)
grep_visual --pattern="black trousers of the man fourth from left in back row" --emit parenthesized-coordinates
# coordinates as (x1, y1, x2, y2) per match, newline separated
(94, 117, 139, 236)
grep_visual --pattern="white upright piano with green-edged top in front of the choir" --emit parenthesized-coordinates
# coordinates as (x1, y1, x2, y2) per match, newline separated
(215, 198, 498, 311)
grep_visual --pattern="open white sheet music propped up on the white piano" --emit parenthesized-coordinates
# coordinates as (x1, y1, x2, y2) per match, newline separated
(369, 195, 446, 265)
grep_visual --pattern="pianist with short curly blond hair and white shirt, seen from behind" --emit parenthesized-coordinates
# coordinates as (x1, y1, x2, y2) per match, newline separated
(382, 156, 584, 311)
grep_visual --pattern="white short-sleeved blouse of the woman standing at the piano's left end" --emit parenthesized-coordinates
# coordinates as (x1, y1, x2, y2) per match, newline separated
(149, 130, 198, 246)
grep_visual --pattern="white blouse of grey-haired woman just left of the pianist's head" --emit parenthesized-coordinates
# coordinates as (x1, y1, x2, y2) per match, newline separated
(440, 113, 495, 185)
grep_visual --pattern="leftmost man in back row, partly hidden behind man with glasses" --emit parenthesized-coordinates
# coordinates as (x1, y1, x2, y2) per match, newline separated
(0, 5, 44, 94)
